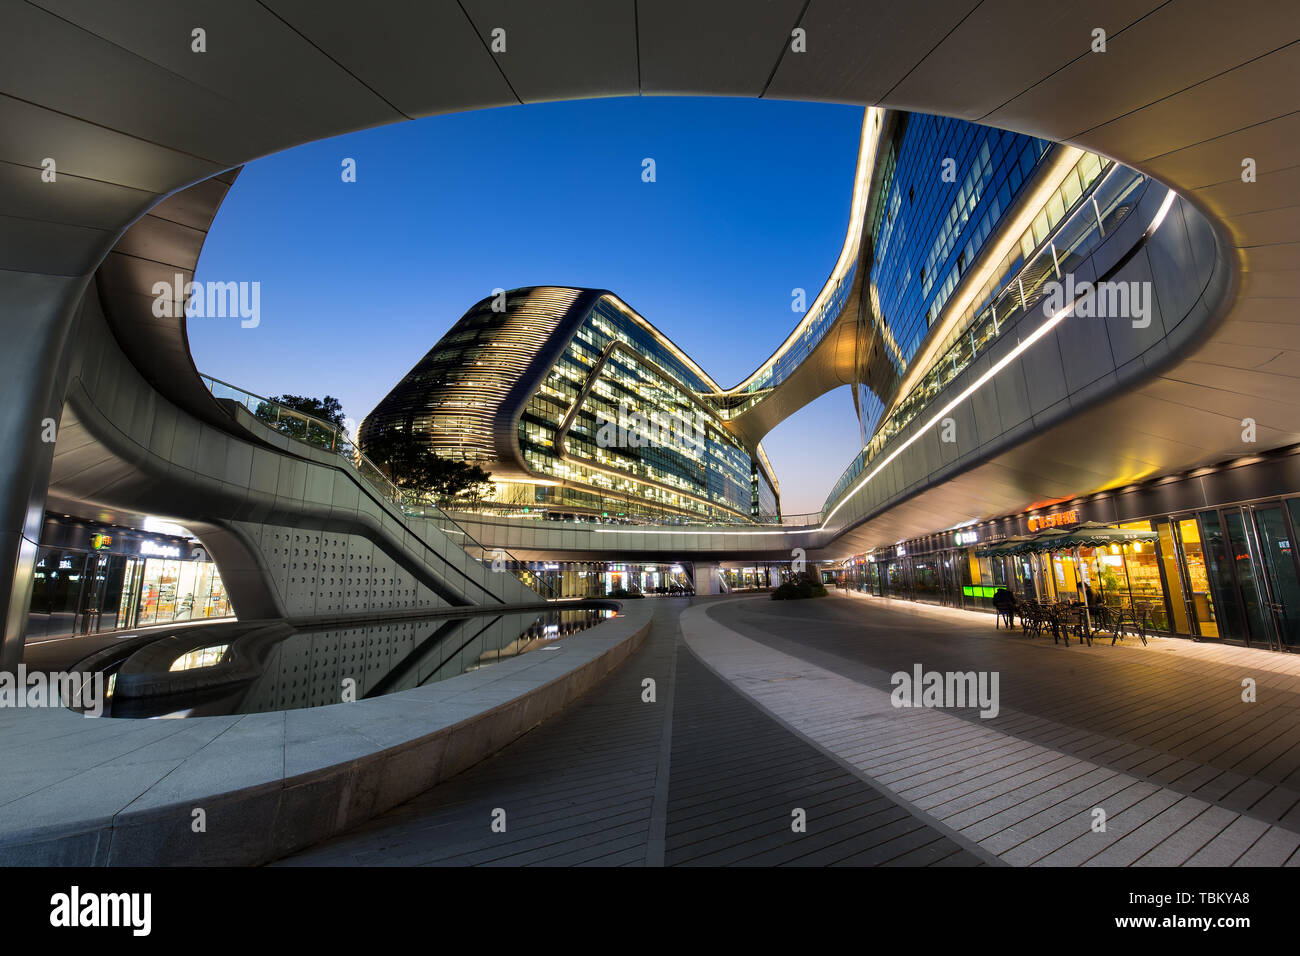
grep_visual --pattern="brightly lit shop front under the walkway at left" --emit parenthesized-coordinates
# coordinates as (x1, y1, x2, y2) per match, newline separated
(27, 515, 234, 640)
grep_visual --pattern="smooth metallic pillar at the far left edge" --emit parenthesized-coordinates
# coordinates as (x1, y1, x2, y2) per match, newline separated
(0, 271, 86, 670)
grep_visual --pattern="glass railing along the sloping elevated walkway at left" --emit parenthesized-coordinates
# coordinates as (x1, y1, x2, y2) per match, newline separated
(199, 375, 551, 598)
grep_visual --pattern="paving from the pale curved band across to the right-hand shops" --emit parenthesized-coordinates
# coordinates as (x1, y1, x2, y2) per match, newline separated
(684, 596, 1300, 866)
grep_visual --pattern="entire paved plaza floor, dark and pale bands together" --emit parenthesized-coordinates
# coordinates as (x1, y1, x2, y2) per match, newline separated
(282, 594, 1300, 866)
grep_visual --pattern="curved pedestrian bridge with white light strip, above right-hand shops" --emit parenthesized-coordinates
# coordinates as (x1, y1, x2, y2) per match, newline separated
(441, 170, 1222, 559)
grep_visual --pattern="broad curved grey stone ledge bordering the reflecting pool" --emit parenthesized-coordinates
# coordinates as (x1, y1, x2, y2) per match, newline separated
(0, 601, 653, 866)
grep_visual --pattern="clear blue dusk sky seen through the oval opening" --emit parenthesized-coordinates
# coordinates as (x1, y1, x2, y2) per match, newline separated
(189, 98, 862, 514)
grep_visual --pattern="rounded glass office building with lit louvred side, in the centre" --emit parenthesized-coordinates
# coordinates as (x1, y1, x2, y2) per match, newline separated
(359, 287, 780, 523)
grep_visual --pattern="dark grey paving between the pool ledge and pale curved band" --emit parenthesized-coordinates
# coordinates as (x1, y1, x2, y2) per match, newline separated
(282, 598, 992, 865)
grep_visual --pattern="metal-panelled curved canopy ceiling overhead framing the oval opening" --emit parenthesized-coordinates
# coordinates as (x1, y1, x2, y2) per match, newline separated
(0, 0, 1300, 538)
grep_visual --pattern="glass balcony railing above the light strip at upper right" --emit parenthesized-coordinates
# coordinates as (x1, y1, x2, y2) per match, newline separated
(823, 164, 1148, 514)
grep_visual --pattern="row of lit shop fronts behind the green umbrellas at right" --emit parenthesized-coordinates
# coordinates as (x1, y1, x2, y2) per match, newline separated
(845, 450, 1300, 650)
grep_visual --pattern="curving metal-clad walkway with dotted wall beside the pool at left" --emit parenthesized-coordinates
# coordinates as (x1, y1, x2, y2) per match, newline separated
(48, 278, 543, 629)
